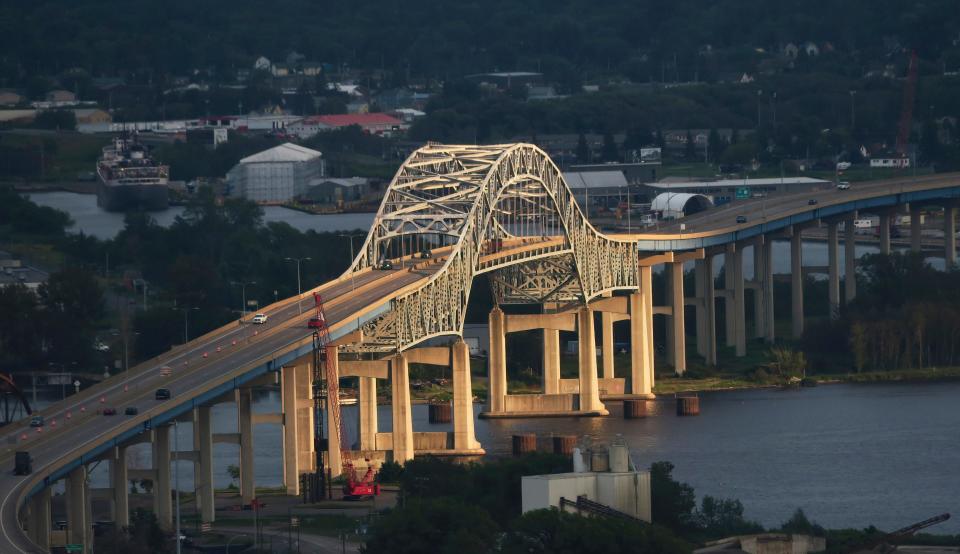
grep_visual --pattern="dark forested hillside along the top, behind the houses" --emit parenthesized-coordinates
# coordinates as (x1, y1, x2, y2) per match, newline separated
(0, 0, 960, 85)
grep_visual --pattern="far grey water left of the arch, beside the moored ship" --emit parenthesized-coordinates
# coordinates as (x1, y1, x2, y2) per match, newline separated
(27, 192, 373, 239)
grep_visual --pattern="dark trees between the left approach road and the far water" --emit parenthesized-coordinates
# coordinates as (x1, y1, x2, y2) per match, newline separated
(0, 187, 360, 371)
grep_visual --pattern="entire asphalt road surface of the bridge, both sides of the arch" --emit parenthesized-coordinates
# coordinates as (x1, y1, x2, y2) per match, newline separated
(0, 174, 960, 554)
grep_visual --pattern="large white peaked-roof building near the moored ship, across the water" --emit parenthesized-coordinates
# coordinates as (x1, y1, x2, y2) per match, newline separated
(227, 142, 325, 204)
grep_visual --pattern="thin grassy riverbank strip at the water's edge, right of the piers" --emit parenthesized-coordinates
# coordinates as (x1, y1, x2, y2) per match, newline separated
(653, 367, 960, 395)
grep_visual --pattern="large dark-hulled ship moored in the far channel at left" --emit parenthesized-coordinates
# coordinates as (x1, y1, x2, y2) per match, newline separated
(97, 134, 170, 212)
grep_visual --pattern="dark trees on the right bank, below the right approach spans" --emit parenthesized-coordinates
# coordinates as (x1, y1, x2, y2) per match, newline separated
(803, 253, 960, 371)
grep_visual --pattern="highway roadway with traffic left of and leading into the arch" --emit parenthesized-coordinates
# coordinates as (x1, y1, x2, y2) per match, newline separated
(0, 260, 440, 554)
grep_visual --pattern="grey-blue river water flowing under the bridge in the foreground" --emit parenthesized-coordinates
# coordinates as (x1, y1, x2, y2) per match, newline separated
(62, 383, 960, 533)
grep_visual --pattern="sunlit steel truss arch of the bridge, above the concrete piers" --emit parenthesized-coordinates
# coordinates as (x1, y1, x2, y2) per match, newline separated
(345, 143, 638, 352)
